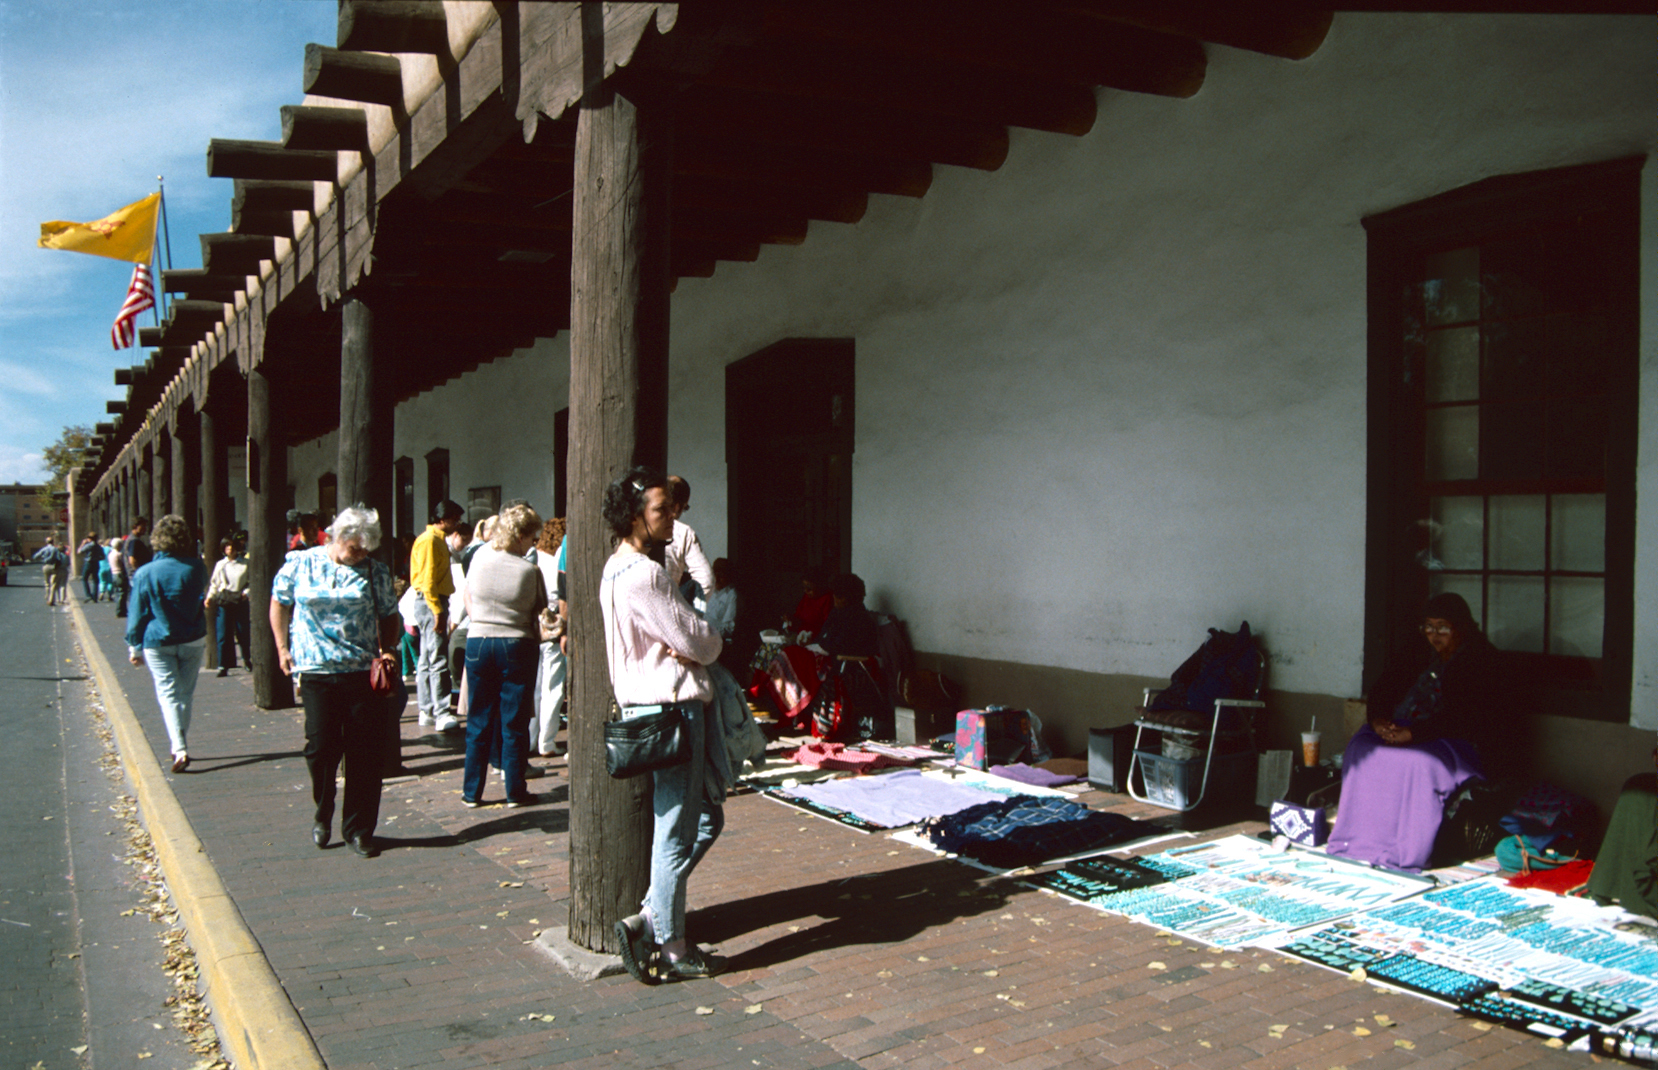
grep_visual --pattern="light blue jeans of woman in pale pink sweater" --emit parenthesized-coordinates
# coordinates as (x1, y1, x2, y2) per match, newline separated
(639, 702, 725, 944)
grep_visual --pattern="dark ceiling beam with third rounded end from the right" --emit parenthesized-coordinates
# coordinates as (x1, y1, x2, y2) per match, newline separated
(701, 36, 1098, 134)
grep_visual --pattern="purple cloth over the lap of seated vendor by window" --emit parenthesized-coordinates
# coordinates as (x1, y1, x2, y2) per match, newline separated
(1325, 725, 1481, 873)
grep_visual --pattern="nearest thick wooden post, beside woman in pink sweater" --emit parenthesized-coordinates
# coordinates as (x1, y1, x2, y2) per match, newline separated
(567, 85, 673, 952)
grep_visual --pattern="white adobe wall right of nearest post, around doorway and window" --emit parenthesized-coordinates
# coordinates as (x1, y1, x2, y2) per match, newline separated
(670, 13, 1658, 710)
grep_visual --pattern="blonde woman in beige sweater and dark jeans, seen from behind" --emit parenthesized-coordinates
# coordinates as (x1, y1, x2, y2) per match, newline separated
(461, 504, 547, 806)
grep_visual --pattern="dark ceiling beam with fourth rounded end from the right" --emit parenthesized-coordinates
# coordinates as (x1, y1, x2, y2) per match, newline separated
(676, 86, 1008, 171)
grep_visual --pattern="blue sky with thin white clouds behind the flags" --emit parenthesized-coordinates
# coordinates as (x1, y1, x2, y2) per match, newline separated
(0, 0, 338, 483)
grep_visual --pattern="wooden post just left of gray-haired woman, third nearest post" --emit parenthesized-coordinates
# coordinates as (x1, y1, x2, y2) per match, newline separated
(247, 365, 293, 710)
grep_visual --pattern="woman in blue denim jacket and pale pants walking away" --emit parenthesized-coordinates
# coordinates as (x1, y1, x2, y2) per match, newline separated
(126, 513, 207, 773)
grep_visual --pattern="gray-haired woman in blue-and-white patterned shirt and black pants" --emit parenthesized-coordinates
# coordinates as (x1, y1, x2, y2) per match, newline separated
(270, 504, 398, 858)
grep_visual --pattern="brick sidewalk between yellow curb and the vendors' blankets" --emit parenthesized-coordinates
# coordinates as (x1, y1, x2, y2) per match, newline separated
(74, 609, 1578, 1070)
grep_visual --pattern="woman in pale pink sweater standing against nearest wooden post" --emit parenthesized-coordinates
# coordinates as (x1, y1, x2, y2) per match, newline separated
(600, 468, 725, 984)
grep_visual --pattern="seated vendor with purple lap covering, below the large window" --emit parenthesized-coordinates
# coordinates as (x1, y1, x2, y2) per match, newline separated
(1326, 594, 1514, 869)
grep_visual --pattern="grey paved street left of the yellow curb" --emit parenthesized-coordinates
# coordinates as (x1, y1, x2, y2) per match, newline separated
(0, 567, 197, 1070)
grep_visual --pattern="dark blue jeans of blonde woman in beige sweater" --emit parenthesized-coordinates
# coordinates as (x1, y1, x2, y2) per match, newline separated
(461, 635, 539, 803)
